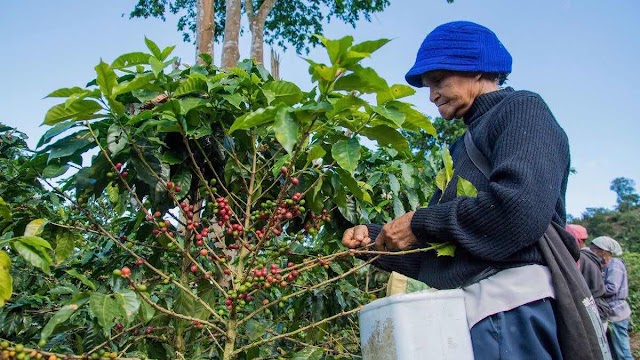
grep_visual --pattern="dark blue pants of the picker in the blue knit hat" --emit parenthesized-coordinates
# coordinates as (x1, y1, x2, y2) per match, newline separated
(471, 299, 562, 360)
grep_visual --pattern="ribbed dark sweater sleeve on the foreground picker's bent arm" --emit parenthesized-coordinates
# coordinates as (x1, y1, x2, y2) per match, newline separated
(411, 93, 569, 261)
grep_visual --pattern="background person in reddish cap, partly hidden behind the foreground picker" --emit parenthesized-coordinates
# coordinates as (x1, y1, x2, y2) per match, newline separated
(566, 224, 611, 326)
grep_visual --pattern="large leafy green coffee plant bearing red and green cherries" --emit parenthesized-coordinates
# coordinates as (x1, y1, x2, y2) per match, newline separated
(0, 37, 436, 359)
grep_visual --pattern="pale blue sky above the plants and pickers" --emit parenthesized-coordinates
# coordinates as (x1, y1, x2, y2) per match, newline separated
(0, 0, 640, 216)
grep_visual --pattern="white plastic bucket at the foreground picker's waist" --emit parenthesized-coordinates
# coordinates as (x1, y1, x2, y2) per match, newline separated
(359, 289, 473, 360)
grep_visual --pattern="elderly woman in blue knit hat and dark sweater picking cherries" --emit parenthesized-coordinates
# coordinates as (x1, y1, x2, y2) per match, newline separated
(342, 21, 569, 359)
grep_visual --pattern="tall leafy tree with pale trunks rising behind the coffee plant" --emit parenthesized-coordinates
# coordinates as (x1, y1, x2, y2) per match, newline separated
(129, 0, 389, 66)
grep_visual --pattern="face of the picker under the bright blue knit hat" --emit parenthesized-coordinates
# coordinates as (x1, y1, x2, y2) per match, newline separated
(422, 70, 498, 120)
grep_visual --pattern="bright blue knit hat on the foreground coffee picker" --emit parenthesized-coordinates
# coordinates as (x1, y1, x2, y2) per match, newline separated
(405, 21, 511, 87)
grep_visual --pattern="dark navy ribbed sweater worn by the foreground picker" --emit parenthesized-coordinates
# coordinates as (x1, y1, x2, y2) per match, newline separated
(369, 88, 569, 289)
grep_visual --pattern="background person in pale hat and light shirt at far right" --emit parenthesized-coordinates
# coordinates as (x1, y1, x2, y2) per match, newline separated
(589, 236, 633, 360)
